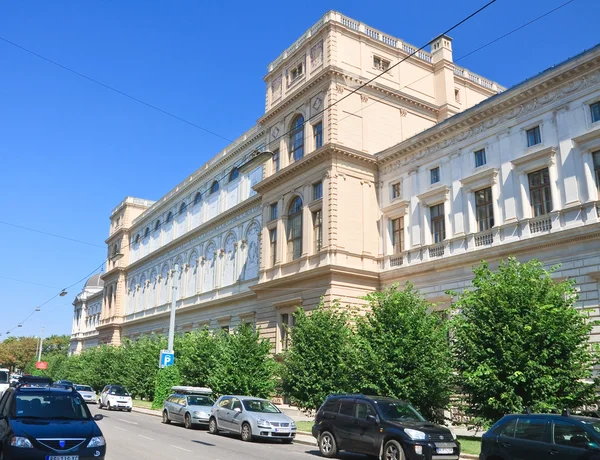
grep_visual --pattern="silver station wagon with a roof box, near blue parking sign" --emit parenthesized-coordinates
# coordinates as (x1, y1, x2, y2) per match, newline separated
(162, 386, 215, 429)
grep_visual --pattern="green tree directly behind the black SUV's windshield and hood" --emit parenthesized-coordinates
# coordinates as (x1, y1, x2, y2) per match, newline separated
(357, 285, 452, 420)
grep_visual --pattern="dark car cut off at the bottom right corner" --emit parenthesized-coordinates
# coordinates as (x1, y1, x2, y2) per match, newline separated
(479, 412, 600, 460)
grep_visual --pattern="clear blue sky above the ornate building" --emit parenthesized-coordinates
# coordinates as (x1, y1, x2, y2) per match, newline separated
(0, 0, 598, 340)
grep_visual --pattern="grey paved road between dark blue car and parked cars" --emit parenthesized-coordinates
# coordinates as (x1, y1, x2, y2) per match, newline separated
(90, 406, 366, 460)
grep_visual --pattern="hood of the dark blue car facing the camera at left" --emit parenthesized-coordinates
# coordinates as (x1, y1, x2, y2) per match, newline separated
(11, 419, 102, 439)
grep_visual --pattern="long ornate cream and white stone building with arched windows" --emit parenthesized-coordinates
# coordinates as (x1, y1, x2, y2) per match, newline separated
(71, 11, 600, 353)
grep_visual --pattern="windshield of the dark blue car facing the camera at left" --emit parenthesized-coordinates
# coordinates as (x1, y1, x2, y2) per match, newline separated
(13, 393, 92, 420)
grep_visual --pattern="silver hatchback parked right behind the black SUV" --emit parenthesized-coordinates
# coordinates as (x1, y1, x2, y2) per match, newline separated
(208, 395, 296, 444)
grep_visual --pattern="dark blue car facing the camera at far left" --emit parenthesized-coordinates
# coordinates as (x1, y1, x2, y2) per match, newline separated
(0, 377, 106, 460)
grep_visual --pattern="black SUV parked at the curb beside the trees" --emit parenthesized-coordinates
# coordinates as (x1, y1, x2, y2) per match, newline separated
(312, 395, 460, 460)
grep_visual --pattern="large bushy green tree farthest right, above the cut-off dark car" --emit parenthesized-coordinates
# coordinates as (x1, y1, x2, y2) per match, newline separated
(453, 258, 599, 425)
